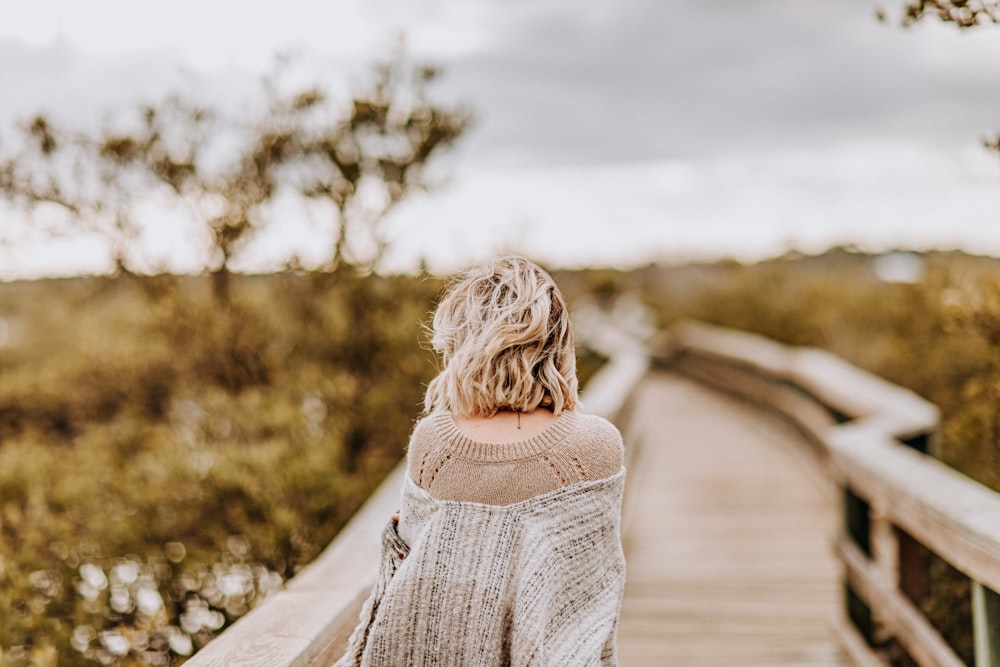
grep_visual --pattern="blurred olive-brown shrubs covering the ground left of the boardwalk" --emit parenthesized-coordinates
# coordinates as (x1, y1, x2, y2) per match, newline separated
(0, 272, 439, 665)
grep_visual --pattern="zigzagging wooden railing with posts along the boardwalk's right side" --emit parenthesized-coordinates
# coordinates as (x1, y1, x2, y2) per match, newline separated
(656, 322, 1000, 667)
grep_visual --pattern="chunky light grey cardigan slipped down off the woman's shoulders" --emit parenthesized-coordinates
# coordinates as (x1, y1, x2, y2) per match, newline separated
(337, 469, 625, 667)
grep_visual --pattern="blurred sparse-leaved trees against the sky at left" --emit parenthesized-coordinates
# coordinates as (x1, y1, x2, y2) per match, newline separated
(0, 54, 470, 304)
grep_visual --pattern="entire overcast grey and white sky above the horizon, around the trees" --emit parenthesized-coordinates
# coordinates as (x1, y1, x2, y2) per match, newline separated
(0, 0, 1000, 278)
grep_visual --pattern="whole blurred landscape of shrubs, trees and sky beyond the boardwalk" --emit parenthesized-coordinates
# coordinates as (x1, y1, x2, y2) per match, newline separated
(0, 0, 1000, 665)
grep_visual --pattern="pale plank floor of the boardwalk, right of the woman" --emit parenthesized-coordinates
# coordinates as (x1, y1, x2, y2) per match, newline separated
(618, 373, 847, 667)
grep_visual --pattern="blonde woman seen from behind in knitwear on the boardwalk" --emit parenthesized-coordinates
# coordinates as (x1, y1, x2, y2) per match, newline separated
(337, 257, 625, 667)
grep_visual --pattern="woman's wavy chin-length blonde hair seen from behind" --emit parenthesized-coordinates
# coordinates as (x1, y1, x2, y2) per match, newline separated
(424, 257, 578, 417)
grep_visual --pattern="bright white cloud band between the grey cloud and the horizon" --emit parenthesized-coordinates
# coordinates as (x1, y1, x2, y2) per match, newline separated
(376, 144, 1000, 271)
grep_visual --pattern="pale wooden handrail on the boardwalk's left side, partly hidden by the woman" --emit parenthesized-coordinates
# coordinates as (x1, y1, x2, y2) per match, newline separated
(185, 312, 649, 667)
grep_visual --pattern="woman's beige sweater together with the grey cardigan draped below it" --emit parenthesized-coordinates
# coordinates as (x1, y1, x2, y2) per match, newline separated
(335, 412, 625, 667)
